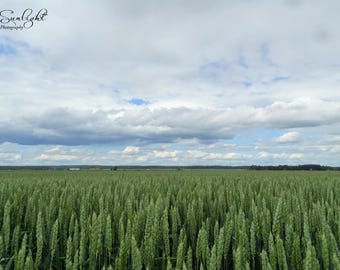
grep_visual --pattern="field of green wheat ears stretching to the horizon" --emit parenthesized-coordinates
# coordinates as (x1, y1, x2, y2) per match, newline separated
(0, 170, 340, 270)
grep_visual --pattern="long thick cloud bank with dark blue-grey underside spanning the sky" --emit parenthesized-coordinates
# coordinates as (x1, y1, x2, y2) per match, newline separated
(0, 99, 340, 147)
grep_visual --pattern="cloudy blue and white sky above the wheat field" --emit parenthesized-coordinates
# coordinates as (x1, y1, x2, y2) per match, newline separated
(0, 0, 340, 166)
